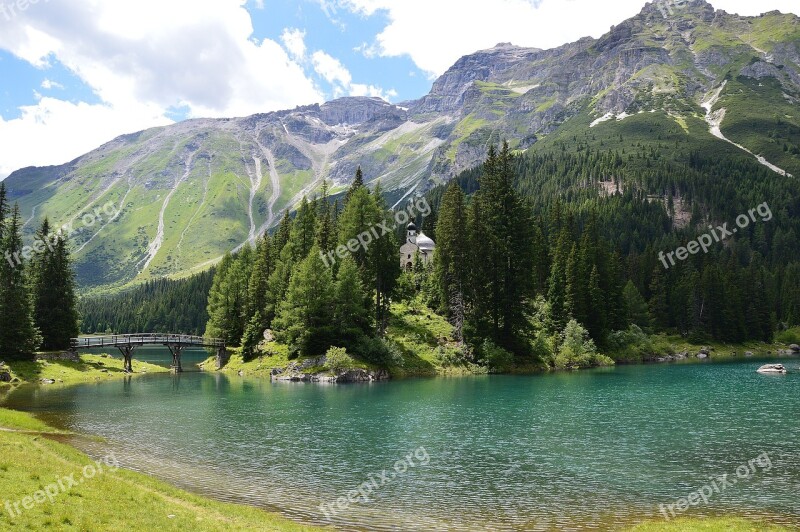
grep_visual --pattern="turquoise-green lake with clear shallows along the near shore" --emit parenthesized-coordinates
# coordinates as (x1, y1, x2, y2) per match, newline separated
(5, 355, 800, 530)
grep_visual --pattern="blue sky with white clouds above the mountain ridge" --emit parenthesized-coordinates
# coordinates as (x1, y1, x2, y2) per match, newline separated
(0, 0, 800, 179)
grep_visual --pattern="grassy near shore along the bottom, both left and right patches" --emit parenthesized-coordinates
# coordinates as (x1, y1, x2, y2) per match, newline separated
(0, 408, 789, 532)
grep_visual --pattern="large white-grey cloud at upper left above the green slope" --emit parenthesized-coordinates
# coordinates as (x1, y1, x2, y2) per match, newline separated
(0, 0, 323, 178)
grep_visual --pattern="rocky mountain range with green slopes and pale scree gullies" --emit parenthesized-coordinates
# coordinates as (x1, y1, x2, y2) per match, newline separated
(6, 0, 800, 289)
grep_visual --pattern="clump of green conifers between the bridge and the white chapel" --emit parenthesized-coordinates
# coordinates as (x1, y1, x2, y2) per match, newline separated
(206, 169, 400, 361)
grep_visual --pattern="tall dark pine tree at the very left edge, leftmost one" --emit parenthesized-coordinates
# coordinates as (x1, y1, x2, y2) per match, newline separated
(0, 204, 41, 360)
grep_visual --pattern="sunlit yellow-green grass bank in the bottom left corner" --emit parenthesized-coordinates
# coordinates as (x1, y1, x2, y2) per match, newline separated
(0, 409, 319, 532)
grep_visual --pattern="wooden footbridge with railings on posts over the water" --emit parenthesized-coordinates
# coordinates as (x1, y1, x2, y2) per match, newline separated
(70, 333, 227, 373)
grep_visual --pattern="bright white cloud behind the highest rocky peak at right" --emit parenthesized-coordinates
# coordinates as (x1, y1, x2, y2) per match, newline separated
(338, 0, 798, 75)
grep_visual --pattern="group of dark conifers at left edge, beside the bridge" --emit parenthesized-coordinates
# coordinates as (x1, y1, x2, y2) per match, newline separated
(0, 183, 78, 360)
